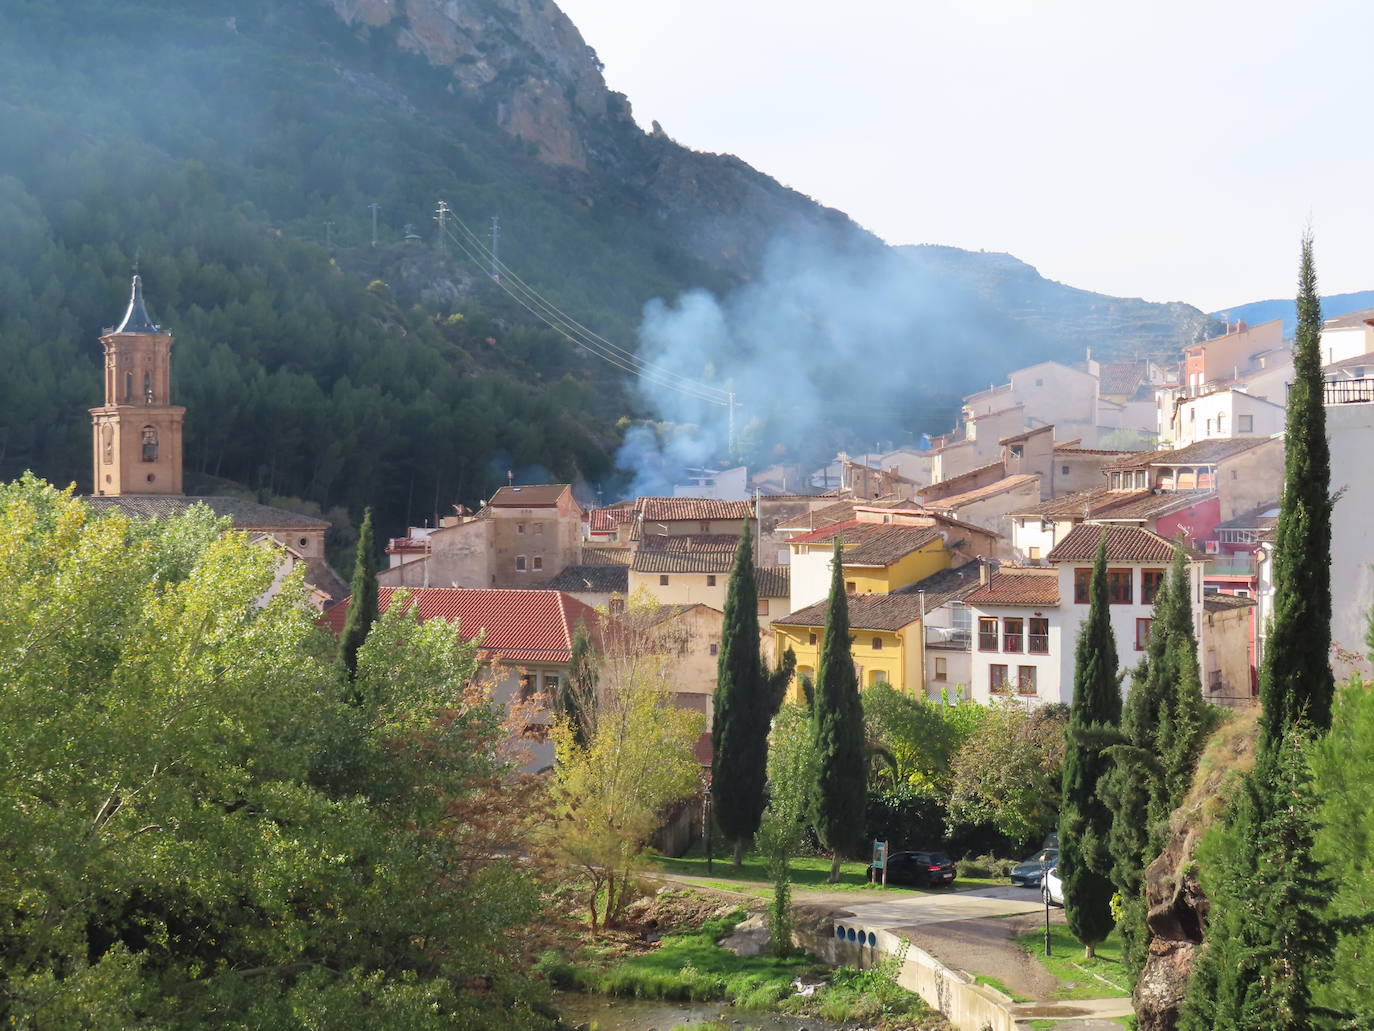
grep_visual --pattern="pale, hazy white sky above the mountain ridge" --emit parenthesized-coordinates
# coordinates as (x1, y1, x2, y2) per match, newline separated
(558, 0, 1374, 311)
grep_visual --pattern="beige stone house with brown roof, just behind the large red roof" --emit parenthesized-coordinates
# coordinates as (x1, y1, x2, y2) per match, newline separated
(378, 484, 585, 588)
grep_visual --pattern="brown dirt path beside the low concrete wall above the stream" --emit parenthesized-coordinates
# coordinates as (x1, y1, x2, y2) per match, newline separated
(893, 916, 1059, 999)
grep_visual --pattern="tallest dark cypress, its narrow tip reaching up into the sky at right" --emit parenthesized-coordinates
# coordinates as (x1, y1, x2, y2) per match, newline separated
(1260, 225, 1336, 746)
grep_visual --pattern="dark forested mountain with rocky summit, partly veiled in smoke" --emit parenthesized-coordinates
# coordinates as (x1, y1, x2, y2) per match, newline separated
(0, 0, 1225, 544)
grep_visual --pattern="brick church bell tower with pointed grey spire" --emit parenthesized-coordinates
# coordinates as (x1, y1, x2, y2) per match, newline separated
(91, 276, 185, 496)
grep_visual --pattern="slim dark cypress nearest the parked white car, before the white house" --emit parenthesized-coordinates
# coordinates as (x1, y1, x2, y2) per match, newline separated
(1059, 531, 1121, 958)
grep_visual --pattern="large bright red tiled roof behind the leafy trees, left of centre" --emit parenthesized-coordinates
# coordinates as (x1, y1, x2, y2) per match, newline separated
(320, 587, 599, 663)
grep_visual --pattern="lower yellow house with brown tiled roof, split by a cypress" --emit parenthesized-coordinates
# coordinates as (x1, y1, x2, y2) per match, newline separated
(774, 594, 925, 697)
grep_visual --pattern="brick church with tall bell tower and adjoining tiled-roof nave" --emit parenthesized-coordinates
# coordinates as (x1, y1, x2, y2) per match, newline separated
(87, 276, 348, 603)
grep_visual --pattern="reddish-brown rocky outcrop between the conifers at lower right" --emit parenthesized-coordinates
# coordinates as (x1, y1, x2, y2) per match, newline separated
(1131, 713, 1254, 1031)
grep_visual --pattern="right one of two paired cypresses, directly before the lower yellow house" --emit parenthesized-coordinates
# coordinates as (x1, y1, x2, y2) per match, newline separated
(812, 536, 868, 884)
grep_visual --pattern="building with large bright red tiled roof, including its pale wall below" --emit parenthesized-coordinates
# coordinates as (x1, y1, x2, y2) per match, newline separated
(320, 587, 600, 770)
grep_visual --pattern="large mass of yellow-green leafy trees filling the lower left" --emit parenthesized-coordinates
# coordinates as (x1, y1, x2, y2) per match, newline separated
(0, 478, 547, 1031)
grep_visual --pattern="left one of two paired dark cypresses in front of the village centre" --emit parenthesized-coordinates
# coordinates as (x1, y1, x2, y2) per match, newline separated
(710, 521, 774, 866)
